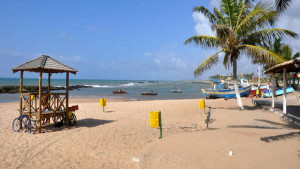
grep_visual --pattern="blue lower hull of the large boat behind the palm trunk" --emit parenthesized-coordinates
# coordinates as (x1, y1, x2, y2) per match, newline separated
(202, 86, 251, 98)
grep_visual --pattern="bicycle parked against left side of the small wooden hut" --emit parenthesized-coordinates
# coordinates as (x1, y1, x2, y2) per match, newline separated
(12, 115, 37, 134)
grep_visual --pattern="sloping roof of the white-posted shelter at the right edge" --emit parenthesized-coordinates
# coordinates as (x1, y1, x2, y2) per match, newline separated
(264, 57, 300, 74)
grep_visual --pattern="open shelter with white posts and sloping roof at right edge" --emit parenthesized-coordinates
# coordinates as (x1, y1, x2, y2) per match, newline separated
(264, 57, 300, 114)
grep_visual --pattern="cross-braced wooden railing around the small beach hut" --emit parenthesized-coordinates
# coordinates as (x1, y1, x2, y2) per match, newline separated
(21, 93, 66, 113)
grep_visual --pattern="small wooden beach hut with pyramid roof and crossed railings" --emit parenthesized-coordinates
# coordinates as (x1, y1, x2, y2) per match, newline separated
(11, 55, 78, 132)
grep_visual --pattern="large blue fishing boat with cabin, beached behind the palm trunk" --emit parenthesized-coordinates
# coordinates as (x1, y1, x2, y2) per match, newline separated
(202, 80, 251, 99)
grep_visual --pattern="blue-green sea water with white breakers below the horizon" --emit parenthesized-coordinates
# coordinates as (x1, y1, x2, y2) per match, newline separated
(0, 78, 210, 102)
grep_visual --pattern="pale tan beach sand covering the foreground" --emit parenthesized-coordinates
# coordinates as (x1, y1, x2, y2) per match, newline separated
(0, 98, 300, 169)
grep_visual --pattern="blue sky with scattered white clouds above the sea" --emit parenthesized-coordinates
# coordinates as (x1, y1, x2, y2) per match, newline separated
(0, 0, 300, 80)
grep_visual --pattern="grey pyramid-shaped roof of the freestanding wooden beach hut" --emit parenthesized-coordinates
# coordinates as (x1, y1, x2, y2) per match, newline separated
(11, 55, 78, 74)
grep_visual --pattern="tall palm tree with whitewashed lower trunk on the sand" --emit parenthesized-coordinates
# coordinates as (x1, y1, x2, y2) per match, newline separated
(185, 0, 297, 109)
